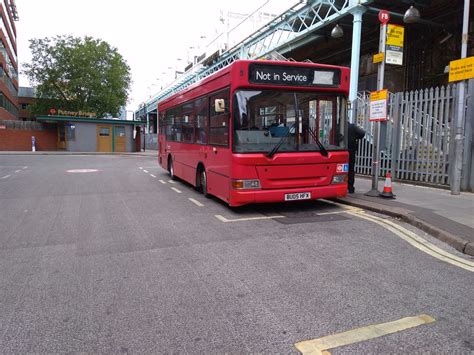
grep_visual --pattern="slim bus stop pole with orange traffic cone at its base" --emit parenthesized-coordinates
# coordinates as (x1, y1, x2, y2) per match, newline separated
(366, 23, 387, 196)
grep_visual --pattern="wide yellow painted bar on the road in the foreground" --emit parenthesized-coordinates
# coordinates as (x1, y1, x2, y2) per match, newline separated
(295, 314, 435, 355)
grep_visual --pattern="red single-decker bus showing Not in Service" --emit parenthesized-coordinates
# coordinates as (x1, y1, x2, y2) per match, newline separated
(158, 60, 349, 206)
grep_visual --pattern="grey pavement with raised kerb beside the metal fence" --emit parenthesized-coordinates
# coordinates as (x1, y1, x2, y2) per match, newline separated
(337, 176, 474, 256)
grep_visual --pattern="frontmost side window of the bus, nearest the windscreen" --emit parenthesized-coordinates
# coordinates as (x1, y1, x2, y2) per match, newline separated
(209, 90, 230, 146)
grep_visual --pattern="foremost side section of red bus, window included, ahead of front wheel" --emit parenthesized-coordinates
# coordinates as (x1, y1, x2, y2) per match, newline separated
(205, 90, 232, 200)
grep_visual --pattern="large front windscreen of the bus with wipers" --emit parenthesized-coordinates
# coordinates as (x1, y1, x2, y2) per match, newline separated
(233, 90, 347, 155)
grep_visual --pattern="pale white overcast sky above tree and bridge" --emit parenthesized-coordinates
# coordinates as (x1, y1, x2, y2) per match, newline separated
(16, 0, 297, 111)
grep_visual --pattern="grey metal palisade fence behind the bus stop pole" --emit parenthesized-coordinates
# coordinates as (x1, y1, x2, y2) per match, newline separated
(356, 84, 457, 185)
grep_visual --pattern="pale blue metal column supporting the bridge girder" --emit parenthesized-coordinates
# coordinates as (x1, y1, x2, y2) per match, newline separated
(349, 6, 367, 123)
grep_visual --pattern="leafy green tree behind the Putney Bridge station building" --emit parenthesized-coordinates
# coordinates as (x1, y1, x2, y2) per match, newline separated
(24, 36, 131, 117)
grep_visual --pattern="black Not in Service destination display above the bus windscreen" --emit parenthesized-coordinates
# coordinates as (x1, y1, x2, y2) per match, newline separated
(249, 64, 341, 87)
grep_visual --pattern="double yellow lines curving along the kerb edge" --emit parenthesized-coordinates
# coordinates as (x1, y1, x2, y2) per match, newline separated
(348, 211, 474, 272)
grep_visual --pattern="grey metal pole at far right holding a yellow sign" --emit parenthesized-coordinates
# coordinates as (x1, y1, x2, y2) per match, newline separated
(451, 0, 469, 195)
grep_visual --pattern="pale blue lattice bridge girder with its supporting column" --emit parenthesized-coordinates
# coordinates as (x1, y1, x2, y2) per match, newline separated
(136, 0, 373, 118)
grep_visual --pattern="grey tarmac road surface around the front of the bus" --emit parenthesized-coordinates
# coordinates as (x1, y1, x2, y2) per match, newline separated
(0, 155, 474, 353)
